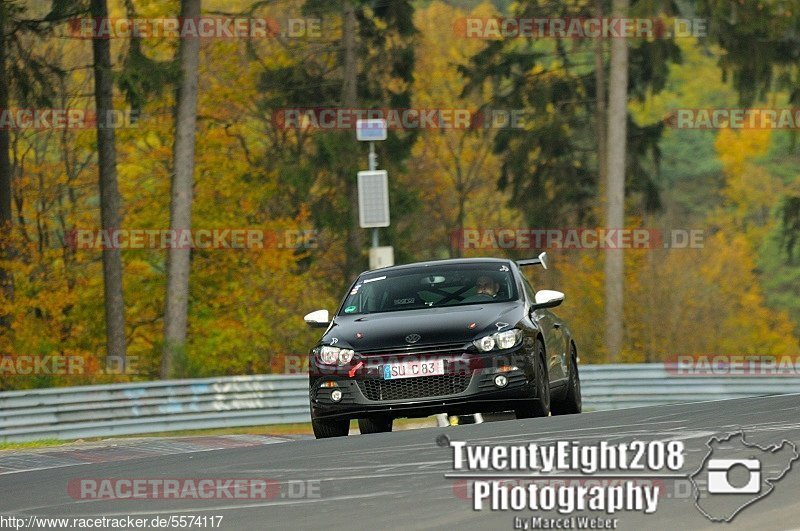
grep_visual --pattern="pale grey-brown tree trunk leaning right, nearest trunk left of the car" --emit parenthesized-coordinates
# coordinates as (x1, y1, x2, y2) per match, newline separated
(161, 0, 201, 378)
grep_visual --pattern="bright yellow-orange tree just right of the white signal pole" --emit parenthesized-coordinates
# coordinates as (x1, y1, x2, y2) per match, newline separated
(410, 2, 526, 259)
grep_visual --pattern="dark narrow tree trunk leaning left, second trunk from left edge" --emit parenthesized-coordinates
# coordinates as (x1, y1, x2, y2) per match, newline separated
(91, 0, 127, 371)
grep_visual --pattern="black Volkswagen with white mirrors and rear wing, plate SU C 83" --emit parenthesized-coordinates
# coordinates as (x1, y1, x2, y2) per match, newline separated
(305, 253, 581, 438)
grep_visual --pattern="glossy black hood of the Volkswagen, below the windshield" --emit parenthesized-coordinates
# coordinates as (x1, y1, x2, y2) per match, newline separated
(321, 301, 524, 352)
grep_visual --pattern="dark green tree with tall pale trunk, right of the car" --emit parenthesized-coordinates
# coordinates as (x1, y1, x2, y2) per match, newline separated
(466, 0, 680, 359)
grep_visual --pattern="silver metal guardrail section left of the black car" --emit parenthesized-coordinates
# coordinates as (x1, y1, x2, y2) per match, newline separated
(0, 375, 310, 441)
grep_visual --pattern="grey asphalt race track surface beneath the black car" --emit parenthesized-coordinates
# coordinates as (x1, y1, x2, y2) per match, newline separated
(0, 395, 800, 531)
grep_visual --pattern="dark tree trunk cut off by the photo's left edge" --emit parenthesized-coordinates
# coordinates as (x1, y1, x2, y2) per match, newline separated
(0, 5, 14, 318)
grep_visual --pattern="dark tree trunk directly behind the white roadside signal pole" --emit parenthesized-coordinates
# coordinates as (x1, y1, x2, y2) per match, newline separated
(342, 0, 364, 285)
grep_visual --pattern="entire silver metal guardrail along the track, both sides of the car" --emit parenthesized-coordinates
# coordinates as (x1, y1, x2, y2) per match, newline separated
(0, 363, 800, 442)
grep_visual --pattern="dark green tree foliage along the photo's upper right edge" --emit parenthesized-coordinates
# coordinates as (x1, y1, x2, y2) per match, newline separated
(698, 0, 800, 330)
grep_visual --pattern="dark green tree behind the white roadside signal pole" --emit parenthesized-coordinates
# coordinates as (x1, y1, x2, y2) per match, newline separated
(253, 0, 416, 289)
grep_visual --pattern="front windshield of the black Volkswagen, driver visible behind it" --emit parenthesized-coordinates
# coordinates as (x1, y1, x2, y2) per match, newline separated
(339, 262, 517, 315)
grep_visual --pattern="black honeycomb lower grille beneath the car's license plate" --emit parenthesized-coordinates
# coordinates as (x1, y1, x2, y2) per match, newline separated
(357, 374, 472, 400)
